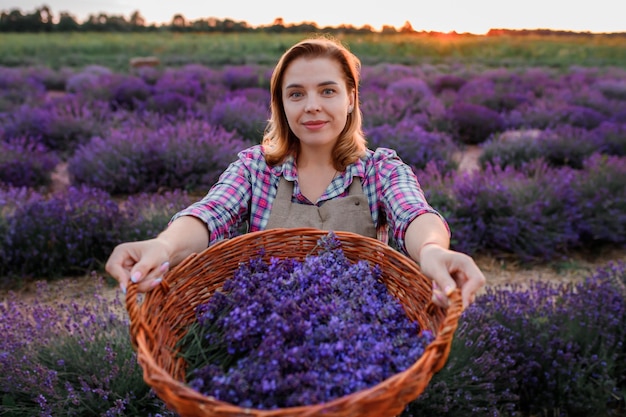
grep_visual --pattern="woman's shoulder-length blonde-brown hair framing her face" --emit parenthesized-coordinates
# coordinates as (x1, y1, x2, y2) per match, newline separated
(263, 37, 367, 171)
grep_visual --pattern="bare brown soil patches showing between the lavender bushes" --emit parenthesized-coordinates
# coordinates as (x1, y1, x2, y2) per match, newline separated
(0, 140, 626, 303)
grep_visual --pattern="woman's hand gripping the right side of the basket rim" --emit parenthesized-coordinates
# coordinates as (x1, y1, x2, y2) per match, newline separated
(420, 244, 487, 308)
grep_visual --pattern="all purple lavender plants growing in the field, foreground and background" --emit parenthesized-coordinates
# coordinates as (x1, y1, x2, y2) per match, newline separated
(0, 34, 626, 417)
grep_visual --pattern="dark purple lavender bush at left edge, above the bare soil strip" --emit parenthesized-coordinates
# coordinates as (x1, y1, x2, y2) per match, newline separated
(0, 187, 120, 278)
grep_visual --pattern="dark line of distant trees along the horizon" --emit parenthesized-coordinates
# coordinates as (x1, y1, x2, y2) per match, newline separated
(0, 5, 626, 36)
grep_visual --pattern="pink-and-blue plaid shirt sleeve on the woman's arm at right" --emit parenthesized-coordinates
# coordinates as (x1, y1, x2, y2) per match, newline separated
(373, 148, 450, 253)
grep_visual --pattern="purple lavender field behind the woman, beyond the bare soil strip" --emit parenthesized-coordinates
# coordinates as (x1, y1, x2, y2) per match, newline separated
(0, 55, 626, 277)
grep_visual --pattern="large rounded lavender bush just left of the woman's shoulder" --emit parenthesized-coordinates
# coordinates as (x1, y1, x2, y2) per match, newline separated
(68, 118, 245, 195)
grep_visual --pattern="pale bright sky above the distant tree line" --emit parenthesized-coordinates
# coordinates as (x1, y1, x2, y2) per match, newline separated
(0, 0, 626, 35)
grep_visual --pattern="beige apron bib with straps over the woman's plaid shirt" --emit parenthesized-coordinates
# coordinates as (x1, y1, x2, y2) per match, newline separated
(266, 177, 377, 238)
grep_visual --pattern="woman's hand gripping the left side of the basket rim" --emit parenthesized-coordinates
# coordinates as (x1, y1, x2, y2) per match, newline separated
(105, 238, 170, 293)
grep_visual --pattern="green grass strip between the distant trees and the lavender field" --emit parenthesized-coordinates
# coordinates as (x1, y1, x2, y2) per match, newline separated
(0, 31, 626, 71)
